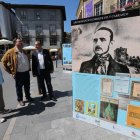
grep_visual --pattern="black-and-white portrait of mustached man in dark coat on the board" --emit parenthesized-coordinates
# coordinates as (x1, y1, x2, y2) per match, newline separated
(80, 27, 129, 75)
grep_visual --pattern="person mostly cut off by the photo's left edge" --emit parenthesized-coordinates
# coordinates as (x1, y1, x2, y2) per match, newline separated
(0, 69, 11, 123)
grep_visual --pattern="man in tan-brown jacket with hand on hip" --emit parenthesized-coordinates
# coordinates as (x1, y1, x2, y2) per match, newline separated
(2, 38, 33, 106)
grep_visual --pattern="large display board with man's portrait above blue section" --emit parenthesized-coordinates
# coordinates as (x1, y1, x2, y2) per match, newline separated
(72, 10, 140, 139)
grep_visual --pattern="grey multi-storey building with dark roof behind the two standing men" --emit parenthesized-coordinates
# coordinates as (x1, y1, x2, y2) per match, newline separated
(12, 4, 66, 53)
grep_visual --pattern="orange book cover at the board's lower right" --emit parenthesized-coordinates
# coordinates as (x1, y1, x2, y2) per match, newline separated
(126, 104, 140, 128)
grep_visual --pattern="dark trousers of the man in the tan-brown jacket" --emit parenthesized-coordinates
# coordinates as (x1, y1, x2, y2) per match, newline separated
(15, 71, 30, 101)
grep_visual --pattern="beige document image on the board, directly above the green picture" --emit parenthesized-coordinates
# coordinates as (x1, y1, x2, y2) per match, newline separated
(101, 78, 112, 96)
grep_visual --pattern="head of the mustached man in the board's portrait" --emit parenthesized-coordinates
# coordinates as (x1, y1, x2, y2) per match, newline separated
(93, 27, 113, 55)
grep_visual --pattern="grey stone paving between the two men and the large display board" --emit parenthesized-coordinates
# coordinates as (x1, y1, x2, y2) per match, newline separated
(1, 62, 132, 140)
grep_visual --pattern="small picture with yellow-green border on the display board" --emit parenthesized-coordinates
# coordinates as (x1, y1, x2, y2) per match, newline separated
(85, 101, 98, 117)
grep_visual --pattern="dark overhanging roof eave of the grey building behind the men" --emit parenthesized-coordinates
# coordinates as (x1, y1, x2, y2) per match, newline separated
(10, 4, 66, 20)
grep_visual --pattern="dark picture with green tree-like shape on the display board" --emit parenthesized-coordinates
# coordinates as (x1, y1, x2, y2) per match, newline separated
(100, 97, 118, 123)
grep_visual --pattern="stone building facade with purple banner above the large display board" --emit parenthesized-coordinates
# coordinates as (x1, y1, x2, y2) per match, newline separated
(76, 0, 140, 19)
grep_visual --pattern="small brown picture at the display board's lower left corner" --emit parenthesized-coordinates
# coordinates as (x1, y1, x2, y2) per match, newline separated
(75, 100, 84, 114)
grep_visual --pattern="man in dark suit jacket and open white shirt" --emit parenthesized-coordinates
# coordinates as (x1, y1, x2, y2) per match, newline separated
(32, 41, 56, 101)
